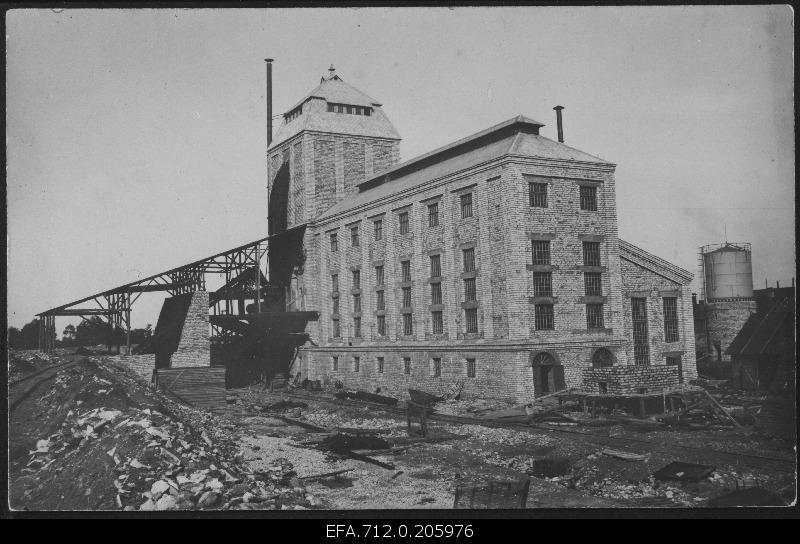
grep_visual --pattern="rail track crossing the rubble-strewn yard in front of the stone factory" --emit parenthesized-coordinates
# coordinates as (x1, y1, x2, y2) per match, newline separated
(247, 392, 796, 474)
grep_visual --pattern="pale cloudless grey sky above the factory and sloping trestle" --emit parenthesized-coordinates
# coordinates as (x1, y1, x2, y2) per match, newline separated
(6, 6, 795, 333)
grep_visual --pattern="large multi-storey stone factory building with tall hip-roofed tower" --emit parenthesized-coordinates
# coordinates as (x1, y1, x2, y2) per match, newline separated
(267, 70, 696, 401)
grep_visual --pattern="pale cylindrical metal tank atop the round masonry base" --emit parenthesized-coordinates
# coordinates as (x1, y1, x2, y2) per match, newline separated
(703, 244, 753, 300)
